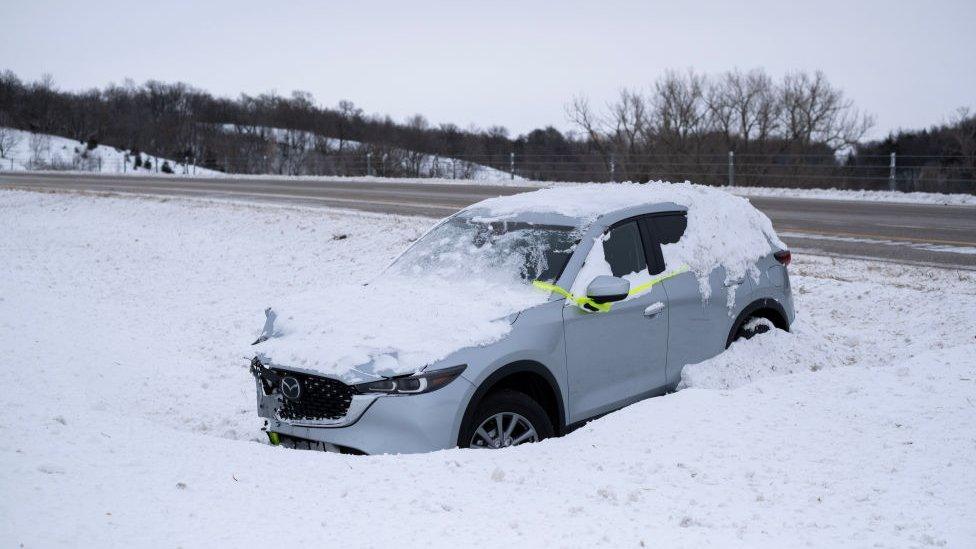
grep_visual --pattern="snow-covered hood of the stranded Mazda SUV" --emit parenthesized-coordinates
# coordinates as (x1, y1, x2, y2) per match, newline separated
(248, 276, 548, 384)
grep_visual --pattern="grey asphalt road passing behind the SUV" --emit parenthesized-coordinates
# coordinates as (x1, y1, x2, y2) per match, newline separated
(0, 172, 976, 270)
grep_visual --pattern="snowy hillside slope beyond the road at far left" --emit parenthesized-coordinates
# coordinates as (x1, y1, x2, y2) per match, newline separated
(0, 127, 219, 176)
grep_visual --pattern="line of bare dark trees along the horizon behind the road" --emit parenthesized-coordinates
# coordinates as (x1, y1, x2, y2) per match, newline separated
(0, 70, 976, 192)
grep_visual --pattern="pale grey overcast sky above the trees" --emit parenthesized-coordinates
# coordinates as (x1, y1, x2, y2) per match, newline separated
(0, 0, 976, 136)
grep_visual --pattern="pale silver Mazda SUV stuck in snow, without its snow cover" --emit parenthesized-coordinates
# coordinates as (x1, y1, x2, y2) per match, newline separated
(251, 188, 794, 454)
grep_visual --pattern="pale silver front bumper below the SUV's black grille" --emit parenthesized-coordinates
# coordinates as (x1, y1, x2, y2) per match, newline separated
(256, 366, 474, 454)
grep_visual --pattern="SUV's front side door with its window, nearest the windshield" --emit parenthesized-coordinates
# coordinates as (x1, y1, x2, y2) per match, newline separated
(563, 218, 668, 421)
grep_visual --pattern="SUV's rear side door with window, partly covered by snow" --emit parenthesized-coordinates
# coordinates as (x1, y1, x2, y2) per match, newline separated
(646, 212, 752, 386)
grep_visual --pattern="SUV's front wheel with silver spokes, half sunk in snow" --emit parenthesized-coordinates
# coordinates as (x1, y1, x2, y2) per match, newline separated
(459, 389, 555, 449)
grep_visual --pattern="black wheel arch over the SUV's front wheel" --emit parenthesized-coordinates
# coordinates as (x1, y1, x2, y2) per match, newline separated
(458, 360, 566, 446)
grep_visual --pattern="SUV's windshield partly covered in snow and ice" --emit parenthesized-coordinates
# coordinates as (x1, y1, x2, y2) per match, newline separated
(390, 216, 579, 282)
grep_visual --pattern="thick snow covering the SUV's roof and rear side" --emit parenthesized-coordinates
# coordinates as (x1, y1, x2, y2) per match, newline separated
(469, 181, 786, 302)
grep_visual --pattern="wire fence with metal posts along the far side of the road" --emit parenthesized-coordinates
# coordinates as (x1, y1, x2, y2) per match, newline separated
(0, 150, 976, 194)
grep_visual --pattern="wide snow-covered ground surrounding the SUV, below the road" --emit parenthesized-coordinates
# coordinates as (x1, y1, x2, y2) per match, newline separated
(0, 191, 976, 547)
